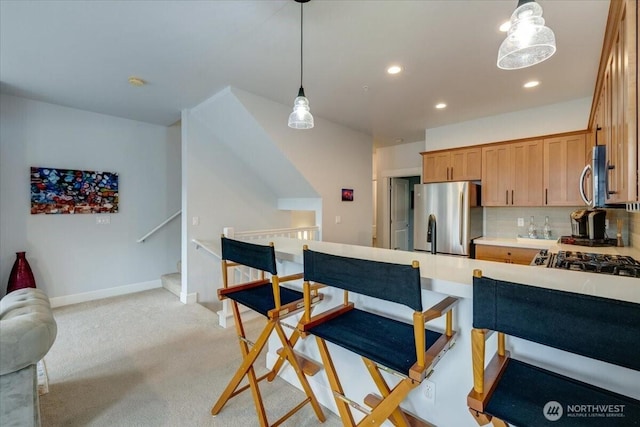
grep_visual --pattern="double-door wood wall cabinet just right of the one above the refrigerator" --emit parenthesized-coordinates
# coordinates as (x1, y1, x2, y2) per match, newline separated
(482, 140, 543, 206)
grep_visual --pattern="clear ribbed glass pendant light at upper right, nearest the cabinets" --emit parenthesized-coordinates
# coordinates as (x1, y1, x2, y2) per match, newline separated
(498, 0, 556, 70)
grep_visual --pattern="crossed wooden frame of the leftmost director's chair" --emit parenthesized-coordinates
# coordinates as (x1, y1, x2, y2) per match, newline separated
(211, 239, 326, 427)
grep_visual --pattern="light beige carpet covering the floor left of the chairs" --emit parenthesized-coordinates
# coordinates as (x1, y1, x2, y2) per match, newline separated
(40, 289, 342, 427)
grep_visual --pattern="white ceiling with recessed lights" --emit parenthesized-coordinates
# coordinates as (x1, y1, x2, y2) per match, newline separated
(0, 0, 609, 147)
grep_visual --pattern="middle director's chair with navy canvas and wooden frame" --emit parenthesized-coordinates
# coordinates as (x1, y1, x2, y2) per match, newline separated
(299, 246, 457, 427)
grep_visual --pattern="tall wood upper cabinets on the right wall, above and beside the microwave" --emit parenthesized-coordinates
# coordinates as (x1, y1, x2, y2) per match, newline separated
(589, 0, 639, 204)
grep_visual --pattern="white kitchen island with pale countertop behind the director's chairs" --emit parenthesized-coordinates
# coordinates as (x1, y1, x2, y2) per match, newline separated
(198, 238, 640, 427)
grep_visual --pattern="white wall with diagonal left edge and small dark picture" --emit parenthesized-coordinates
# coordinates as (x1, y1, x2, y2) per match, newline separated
(232, 88, 373, 246)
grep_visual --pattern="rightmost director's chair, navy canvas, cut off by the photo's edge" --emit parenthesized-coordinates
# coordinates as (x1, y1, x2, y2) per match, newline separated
(467, 270, 640, 427)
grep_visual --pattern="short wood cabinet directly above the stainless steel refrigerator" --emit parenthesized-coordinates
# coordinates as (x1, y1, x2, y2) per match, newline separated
(421, 147, 482, 184)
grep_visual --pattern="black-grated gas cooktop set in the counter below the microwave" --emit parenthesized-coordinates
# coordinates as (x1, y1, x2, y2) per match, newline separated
(531, 249, 640, 278)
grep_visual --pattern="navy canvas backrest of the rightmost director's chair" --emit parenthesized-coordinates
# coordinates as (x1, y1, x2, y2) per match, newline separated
(473, 277, 640, 370)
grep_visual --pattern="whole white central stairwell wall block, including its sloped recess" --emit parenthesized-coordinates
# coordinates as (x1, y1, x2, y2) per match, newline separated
(182, 89, 373, 302)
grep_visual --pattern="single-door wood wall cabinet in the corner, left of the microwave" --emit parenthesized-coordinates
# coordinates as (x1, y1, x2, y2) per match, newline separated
(543, 133, 587, 206)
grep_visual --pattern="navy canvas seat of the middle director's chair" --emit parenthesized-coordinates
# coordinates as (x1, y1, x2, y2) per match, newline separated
(308, 309, 442, 375)
